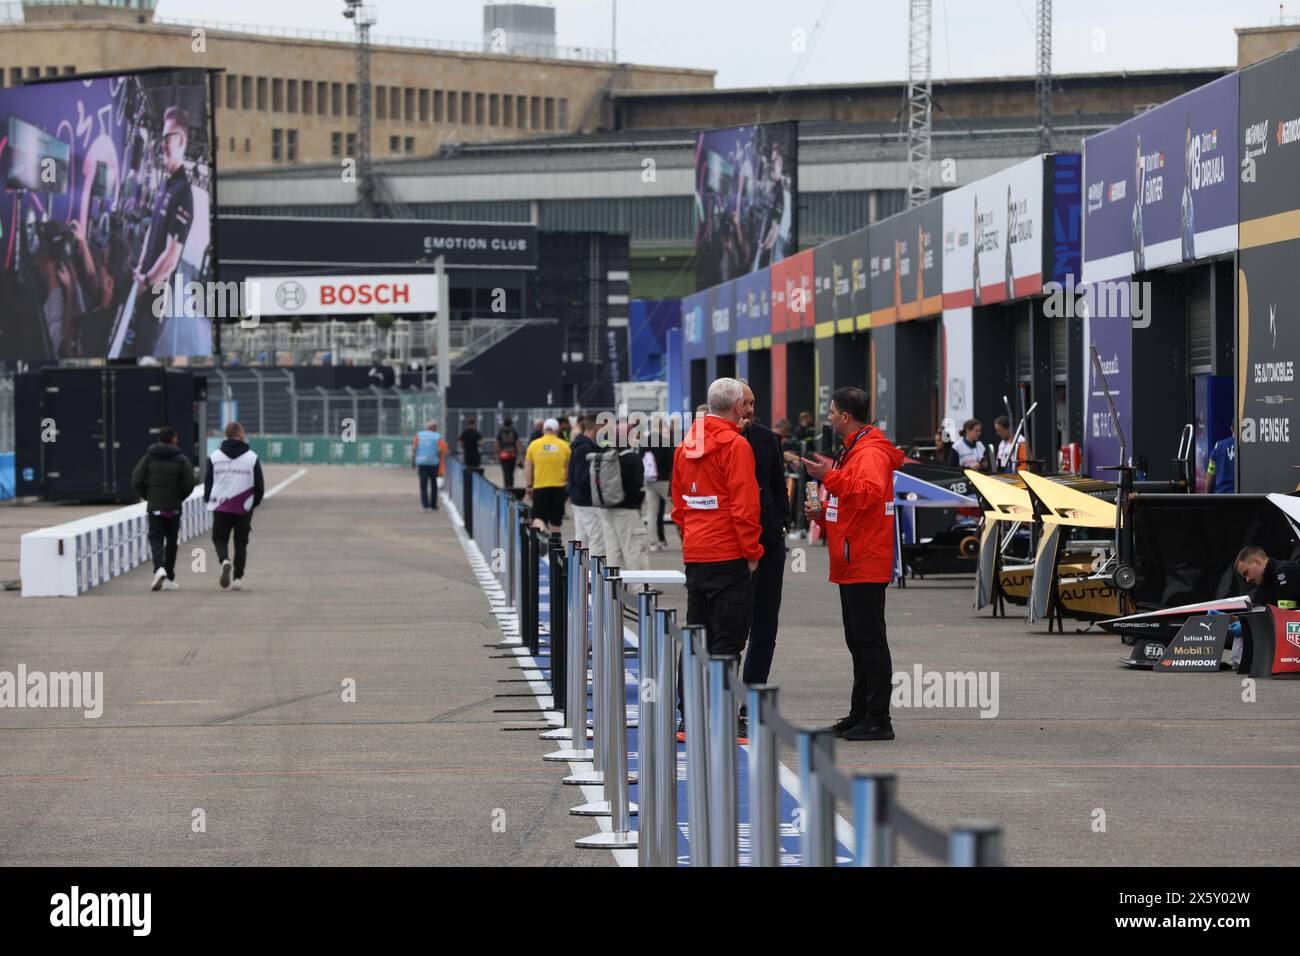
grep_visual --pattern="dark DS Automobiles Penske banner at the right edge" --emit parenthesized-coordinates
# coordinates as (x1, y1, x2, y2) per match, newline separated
(1236, 239, 1300, 493)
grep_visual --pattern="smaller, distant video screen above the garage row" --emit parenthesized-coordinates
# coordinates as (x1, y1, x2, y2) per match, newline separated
(696, 122, 800, 289)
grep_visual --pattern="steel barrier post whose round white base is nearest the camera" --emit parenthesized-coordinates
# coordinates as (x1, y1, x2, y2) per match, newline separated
(575, 568, 637, 849)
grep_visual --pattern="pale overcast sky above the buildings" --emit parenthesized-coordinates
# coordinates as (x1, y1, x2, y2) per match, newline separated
(159, 0, 1300, 86)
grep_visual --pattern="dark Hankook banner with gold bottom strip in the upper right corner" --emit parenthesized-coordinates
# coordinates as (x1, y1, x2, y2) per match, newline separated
(1238, 49, 1300, 230)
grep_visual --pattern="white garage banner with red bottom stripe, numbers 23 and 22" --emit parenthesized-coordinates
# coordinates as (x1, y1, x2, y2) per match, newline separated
(946, 156, 1044, 306)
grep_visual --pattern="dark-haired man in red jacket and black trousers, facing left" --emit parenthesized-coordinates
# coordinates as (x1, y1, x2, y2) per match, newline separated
(802, 388, 902, 740)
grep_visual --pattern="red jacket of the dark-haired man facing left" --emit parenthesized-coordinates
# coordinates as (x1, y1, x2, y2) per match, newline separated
(816, 425, 902, 584)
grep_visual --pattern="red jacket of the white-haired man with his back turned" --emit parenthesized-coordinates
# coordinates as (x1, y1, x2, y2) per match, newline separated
(672, 415, 763, 564)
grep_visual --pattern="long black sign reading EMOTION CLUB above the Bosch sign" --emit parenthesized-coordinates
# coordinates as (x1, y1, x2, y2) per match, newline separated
(217, 216, 537, 276)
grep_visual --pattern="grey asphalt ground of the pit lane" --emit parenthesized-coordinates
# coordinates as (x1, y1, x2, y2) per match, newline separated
(0, 468, 1300, 866)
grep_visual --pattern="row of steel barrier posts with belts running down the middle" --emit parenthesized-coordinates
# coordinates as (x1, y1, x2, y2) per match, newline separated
(446, 459, 1002, 866)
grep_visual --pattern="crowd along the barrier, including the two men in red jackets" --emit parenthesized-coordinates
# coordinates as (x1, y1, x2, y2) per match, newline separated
(436, 378, 902, 743)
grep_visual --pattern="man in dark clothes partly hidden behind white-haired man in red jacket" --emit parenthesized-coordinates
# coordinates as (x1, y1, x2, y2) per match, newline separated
(740, 382, 790, 736)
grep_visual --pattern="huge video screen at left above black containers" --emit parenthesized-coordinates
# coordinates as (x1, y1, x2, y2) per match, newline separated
(0, 70, 215, 362)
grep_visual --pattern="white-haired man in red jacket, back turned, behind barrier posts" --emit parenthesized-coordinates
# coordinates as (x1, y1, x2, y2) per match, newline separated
(672, 378, 763, 737)
